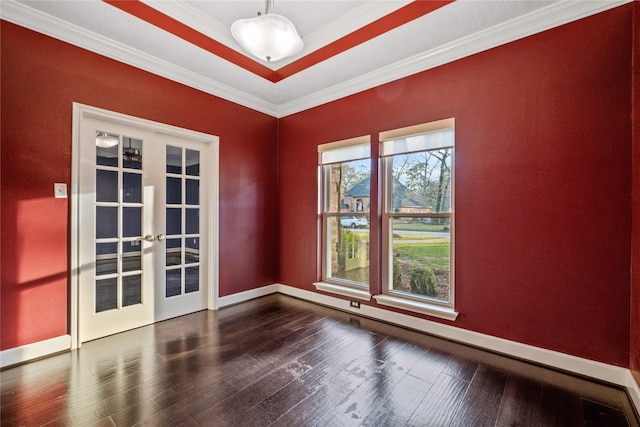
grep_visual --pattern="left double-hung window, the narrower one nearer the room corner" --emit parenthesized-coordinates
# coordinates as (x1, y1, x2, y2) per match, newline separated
(316, 137, 371, 299)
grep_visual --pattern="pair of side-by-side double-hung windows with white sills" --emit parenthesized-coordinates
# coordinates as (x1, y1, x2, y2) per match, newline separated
(314, 119, 458, 320)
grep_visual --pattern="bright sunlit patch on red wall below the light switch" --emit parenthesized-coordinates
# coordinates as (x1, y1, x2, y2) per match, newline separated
(0, 197, 68, 350)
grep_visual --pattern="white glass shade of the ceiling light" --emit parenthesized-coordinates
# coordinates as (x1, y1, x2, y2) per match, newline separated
(231, 13, 303, 61)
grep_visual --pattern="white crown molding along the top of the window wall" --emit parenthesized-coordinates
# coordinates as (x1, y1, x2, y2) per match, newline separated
(277, 0, 633, 118)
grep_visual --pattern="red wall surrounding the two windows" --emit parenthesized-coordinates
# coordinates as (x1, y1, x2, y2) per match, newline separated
(279, 5, 637, 366)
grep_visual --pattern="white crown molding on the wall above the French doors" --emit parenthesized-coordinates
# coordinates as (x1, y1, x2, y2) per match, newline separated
(1, 0, 277, 116)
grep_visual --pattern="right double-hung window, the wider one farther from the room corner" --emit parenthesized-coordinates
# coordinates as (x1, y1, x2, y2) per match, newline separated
(376, 119, 454, 307)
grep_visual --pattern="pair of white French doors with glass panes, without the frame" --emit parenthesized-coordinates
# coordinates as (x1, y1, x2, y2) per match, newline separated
(78, 117, 209, 342)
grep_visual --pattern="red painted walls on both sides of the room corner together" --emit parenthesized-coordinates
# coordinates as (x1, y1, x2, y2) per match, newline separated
(0, 4, 640, 372)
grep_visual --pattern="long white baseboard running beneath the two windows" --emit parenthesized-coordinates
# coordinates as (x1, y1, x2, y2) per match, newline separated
(277, 284, 640, 412)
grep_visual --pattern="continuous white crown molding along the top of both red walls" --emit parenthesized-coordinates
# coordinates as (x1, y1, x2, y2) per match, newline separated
(0, 0, 633, 118)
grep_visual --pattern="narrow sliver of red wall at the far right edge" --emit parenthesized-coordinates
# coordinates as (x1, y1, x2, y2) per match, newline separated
(629, 2, 640, 385)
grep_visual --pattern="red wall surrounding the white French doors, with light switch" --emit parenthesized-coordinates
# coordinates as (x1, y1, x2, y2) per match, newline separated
(0, 21, 278, 349)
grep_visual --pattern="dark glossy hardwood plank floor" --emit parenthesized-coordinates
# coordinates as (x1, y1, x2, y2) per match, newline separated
(1, 295, 639, 427)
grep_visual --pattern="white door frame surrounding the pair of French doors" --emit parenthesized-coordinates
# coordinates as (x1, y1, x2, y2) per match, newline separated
(69, 102, 220, 349)
